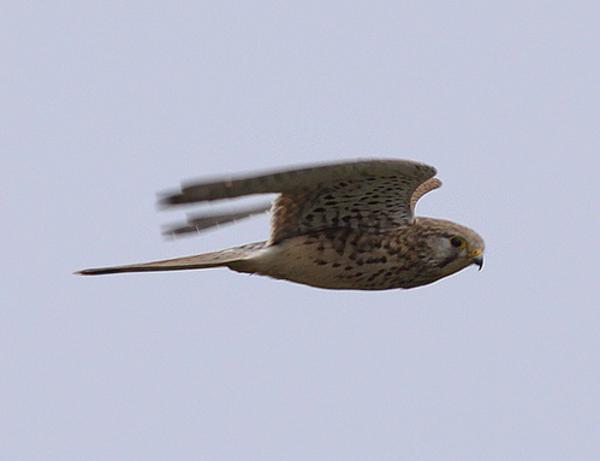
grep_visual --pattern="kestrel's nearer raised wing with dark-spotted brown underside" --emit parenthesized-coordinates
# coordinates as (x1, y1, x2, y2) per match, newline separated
(161, 160, 439, 243)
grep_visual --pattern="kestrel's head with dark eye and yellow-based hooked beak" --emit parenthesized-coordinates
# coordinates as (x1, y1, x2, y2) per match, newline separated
(415, 218, 485, 281)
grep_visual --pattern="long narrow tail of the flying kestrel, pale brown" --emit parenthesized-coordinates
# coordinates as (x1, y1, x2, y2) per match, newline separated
(75, 242, 266, 275)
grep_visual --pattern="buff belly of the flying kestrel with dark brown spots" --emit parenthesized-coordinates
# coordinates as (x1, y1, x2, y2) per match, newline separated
(245, 236, 402, 290)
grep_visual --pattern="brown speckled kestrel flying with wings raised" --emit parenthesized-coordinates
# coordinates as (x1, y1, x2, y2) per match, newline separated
(77, 158, 485, 290)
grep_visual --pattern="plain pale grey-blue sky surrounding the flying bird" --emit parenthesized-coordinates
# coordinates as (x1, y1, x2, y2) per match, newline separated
(0, 1, 600, 461)
